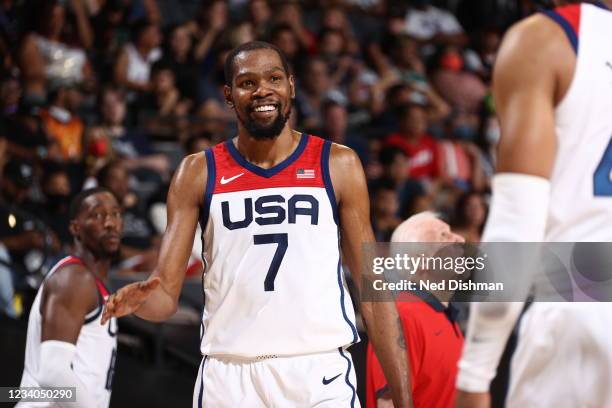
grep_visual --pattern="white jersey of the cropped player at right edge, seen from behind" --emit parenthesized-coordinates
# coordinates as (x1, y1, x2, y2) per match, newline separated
(544, 4, 612, 242)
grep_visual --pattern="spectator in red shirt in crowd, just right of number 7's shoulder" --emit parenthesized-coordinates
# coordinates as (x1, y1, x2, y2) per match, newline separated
(385, 102, 439, 179)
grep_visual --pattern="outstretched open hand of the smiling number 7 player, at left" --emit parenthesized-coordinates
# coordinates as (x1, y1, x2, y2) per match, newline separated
(100, 278, 160, 324)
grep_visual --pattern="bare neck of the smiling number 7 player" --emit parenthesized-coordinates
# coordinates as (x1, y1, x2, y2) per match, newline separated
(233, 126, 301, 168)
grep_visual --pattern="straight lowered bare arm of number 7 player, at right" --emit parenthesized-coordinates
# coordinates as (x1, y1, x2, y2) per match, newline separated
(330, 145, 412, 408)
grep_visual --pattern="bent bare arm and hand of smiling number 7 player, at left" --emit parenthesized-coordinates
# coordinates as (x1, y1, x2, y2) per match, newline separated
(102, 153, 207, 323)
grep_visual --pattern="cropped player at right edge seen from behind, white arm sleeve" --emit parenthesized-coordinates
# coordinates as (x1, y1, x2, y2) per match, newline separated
(457, 1, 612, 407)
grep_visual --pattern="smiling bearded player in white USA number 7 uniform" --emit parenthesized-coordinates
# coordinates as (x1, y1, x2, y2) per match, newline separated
(104, 42, 411, 408)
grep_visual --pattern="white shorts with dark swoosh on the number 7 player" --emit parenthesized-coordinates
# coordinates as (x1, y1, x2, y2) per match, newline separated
(193, 348, 360, 408)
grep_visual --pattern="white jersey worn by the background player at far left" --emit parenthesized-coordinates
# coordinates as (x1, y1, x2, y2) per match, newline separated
(18, 256, 117, 408)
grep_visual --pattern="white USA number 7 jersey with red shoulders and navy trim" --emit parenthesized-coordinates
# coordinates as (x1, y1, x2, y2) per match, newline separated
(200, 134, 359, 358)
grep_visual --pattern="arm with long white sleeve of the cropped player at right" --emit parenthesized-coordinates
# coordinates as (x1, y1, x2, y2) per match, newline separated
(457, 14, 576, 407)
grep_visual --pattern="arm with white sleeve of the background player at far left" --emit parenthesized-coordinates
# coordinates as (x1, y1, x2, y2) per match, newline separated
(35, 265, 98, 408)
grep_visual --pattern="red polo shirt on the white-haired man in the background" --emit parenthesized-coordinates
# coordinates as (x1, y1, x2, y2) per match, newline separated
(366, 292, 463, 408)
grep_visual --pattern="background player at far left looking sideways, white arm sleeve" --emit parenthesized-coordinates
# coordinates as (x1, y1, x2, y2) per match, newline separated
(17, 188, 123, 408)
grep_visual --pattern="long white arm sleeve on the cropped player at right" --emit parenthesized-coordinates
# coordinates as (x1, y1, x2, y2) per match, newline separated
(457, 173, 550, 392)
